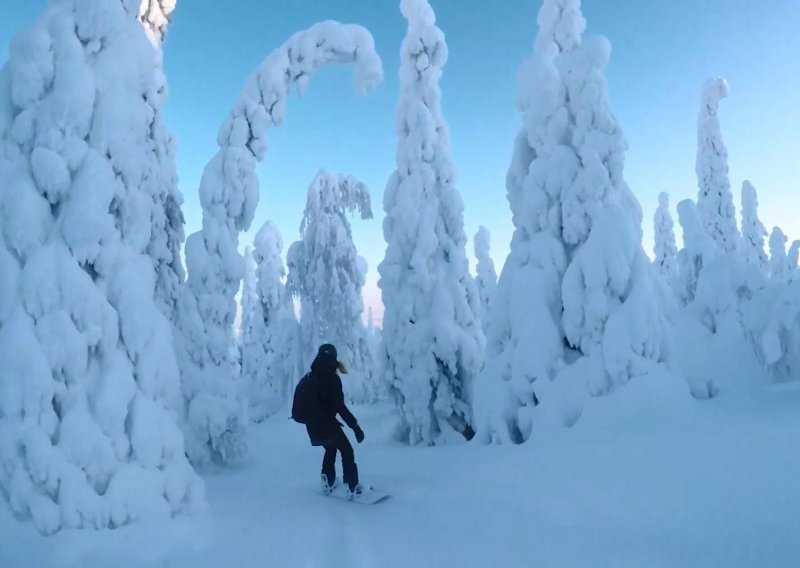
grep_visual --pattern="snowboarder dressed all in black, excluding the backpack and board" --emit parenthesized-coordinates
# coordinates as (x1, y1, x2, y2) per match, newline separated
(306, 343, 364, 494)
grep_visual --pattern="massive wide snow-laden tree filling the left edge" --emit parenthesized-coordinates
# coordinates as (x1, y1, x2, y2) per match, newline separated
(0, 0, 203, 533)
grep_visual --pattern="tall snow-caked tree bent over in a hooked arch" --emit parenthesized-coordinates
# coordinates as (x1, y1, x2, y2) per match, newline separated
(178, 21, 382, 464)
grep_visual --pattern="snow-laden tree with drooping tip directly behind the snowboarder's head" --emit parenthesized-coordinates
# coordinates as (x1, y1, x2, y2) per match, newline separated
(287, 170, 373, 401)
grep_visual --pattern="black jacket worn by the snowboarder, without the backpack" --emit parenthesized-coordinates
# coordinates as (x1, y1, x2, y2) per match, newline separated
(306, 357, 358, 446)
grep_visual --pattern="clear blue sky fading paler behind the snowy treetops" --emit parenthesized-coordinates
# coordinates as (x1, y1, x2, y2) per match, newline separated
(0, 0, 800, 324)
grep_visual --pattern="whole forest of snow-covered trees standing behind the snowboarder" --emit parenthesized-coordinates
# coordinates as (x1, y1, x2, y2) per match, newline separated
(0, 0, 800, 534)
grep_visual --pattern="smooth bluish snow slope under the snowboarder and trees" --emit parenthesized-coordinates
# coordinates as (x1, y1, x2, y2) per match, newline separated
(0, 381, 800, 568)
